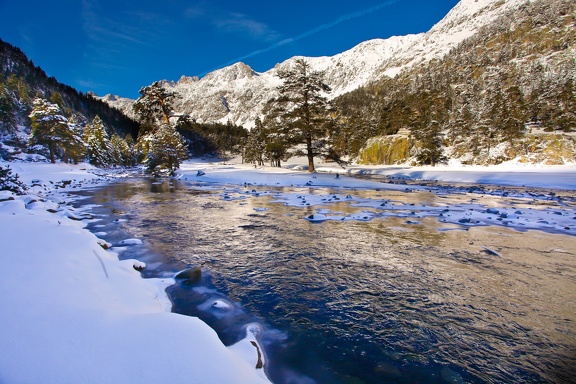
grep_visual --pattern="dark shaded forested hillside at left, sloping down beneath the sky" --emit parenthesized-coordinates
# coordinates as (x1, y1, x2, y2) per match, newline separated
(0, 40, 139, 153)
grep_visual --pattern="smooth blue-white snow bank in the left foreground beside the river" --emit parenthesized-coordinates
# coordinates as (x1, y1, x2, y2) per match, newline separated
(0, 164, 269, 384)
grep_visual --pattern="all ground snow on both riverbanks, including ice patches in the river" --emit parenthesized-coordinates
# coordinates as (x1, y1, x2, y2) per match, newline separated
(0, 159, 576, 383)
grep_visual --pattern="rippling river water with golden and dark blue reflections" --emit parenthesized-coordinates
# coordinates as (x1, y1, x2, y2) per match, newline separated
(81, 180, 576, 383)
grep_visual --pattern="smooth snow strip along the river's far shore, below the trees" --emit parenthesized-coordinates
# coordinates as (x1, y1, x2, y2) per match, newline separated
(178, 158, 576, 190)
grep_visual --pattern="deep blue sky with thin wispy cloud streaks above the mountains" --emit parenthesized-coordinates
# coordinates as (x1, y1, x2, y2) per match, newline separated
(0, 0, 458, 98)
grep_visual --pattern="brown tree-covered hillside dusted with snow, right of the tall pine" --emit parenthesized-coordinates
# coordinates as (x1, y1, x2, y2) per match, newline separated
(336, 0, 576, 164)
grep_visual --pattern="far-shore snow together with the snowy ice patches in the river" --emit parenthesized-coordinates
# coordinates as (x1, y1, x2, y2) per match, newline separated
(177, 159, 576, 235)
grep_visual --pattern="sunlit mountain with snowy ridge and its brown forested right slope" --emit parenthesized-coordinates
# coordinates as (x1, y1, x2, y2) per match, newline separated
(97, 0, 576, 165)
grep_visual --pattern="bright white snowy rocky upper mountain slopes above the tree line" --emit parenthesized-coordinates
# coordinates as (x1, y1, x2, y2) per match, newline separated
(103, 0, 528, 128)
